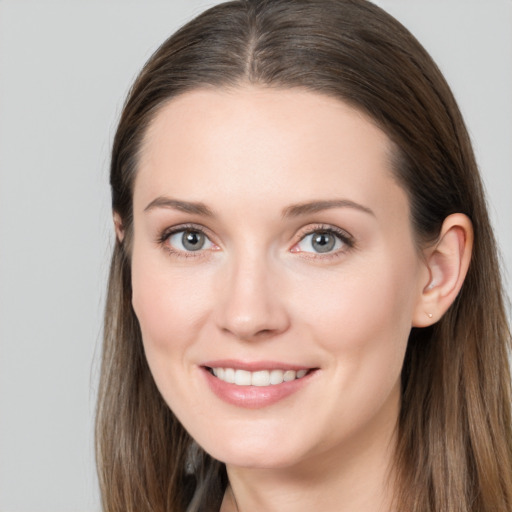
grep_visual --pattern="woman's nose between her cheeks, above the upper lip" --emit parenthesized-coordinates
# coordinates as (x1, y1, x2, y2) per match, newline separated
(216, 251, 290, 341)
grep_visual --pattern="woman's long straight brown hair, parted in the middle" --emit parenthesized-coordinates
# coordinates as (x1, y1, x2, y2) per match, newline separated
(96, 0, 512, 512)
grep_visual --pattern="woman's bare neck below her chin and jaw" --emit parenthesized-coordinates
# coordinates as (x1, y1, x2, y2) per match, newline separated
(221, 420, 395, 512)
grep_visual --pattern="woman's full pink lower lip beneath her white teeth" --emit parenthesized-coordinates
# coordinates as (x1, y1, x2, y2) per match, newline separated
(202, 367, 316, 409)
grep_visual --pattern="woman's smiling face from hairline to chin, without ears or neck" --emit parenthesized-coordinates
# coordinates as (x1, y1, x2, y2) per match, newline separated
(132, 86, 428, 467)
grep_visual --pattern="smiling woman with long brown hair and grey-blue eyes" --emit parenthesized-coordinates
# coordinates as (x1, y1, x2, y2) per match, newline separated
(97, 0, 512, 512)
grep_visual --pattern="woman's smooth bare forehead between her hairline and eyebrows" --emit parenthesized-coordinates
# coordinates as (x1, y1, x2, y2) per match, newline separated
(134, 86, 402, 222)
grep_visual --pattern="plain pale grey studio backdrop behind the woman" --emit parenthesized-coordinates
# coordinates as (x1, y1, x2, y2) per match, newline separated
(0, 0, 512, 512)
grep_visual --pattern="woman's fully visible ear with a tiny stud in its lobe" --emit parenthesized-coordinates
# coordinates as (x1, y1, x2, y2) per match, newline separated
(412, 213, 473, 327)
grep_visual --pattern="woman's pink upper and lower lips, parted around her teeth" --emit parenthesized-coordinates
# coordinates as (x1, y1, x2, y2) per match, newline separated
(201, 361, 316, 409)
